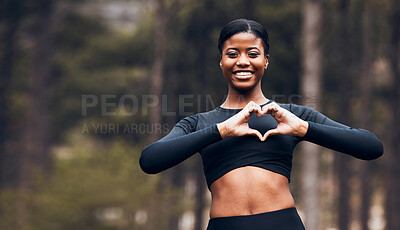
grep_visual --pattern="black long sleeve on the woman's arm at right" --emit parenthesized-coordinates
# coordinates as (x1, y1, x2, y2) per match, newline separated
(291, 105, 383, 160)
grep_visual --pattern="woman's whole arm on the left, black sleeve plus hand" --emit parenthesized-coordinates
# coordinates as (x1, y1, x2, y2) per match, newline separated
(139, 102, 268, 174)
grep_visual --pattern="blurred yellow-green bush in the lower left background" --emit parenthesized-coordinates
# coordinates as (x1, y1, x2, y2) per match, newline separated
(0, 127, 183, 230)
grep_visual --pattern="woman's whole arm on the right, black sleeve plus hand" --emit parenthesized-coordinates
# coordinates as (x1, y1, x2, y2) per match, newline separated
(262, 103, 383, 160)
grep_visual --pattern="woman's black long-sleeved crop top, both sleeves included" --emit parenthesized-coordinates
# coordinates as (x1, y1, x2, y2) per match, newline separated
(139, 100, 383, 188)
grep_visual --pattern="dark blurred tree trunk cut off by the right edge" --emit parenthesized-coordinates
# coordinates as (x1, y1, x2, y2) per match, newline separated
(385, 0, 400, 230)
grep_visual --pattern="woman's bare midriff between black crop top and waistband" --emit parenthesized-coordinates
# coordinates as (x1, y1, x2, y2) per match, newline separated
(210, 166, 294, 218)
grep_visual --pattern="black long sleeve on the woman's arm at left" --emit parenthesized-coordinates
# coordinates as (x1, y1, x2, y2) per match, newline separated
(139, 115, 222, 174)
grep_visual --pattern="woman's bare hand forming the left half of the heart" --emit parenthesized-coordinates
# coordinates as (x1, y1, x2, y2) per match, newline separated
(217, 101, 265, 141)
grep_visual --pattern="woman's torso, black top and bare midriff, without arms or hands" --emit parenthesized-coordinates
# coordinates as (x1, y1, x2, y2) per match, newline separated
(178, 104, 308, 218)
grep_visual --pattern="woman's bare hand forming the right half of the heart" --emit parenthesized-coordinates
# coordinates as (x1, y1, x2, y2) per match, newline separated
(262, 102, 308, 140)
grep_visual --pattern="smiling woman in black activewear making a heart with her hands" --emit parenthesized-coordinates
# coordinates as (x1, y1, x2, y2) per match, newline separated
(140, 19, 383, 230)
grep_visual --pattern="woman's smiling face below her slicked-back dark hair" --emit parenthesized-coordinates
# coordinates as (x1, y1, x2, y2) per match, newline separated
(220, 32, 269, 92)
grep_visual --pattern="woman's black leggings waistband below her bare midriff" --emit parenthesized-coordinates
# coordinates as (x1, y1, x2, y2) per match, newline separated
(207, 207, 305, 230)
